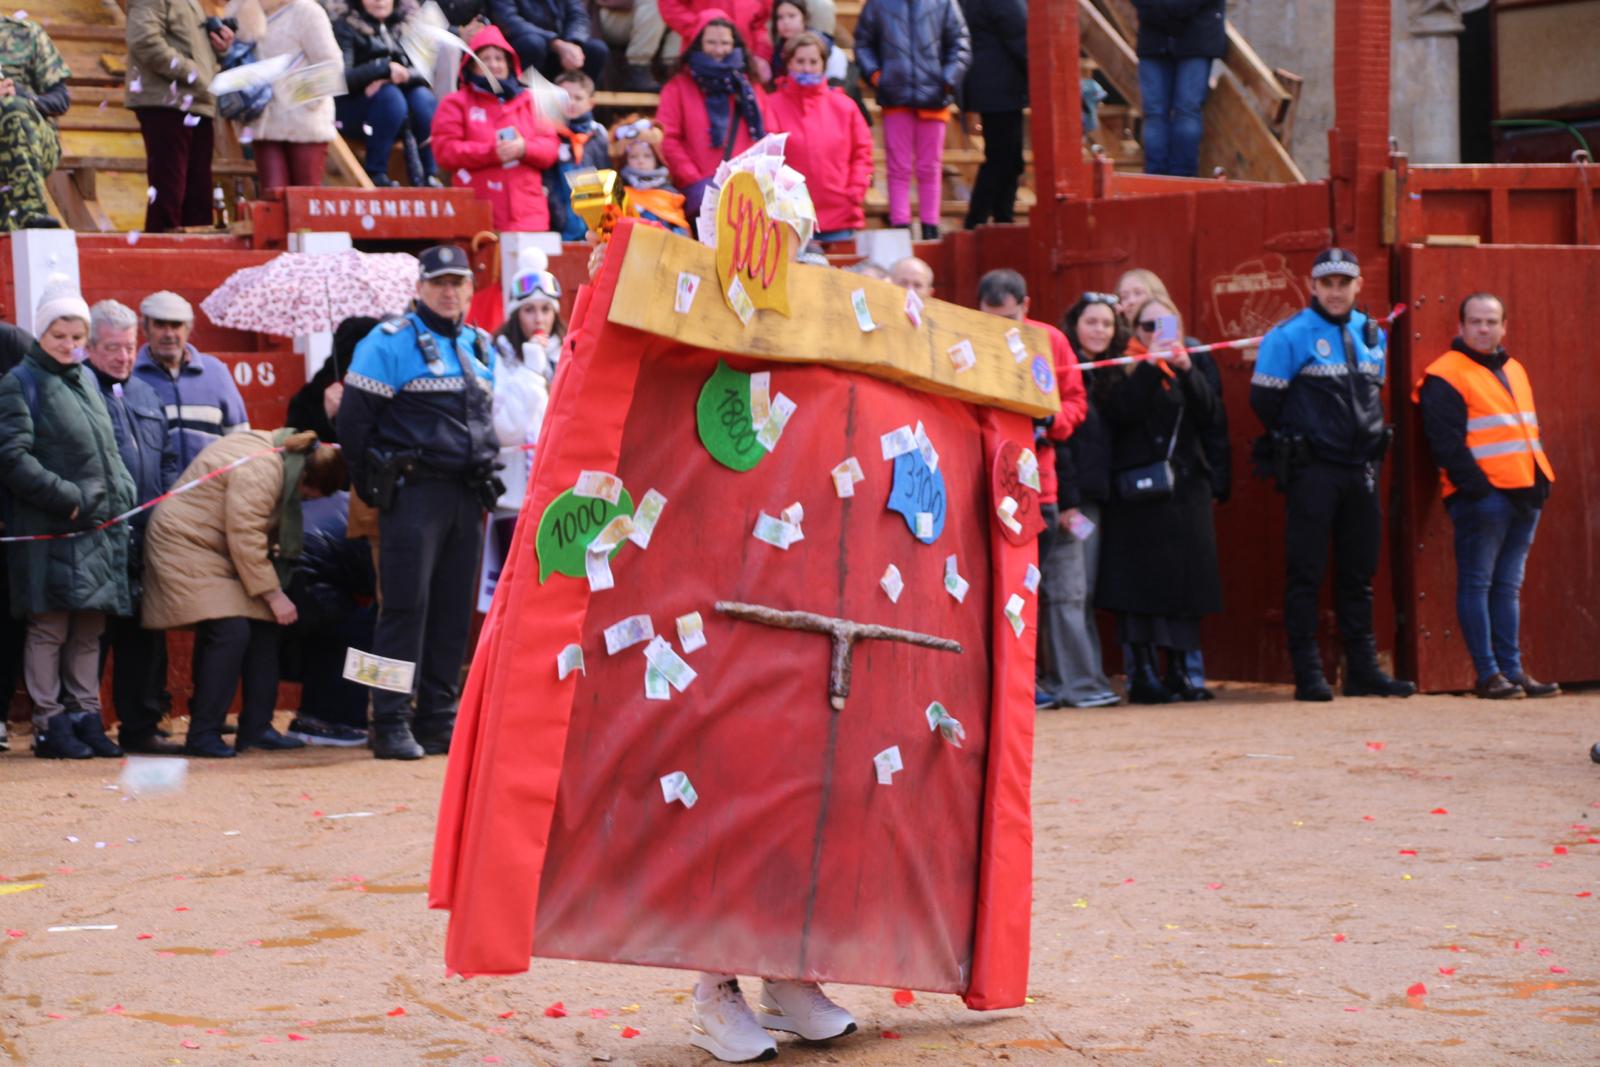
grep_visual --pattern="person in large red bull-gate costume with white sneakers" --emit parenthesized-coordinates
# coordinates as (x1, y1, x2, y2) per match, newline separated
(430, 174, 1059, 1062)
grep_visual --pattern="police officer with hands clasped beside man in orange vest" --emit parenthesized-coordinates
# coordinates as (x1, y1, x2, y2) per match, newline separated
(1250, 248, 1416, 701)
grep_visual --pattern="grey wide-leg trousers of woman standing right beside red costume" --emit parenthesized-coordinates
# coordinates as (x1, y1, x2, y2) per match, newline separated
(1038, 502, 1112, 704)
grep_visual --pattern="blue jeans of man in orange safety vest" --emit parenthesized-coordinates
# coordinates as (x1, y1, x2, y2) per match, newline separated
(1445, 491, 1539, 681)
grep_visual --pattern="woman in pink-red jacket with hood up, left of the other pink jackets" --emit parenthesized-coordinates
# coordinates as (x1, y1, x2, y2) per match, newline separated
(434, 26, 562, 234)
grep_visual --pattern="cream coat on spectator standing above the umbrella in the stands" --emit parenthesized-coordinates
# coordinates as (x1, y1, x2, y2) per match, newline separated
(227, 0, 344, 144)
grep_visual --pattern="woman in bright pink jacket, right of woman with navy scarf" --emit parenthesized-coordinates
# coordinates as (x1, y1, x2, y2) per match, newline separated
(766, 32, 872, 242)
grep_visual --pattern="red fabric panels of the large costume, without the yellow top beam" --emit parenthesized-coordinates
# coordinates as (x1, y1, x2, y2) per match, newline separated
(429, 221, 1037, 1009)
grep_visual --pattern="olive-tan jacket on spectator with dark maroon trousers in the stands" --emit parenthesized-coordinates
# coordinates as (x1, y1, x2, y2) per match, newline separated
(126, 0, 218, 118)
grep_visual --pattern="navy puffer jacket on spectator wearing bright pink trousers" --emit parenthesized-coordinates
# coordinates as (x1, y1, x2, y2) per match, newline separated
(856, 0, 973, 107)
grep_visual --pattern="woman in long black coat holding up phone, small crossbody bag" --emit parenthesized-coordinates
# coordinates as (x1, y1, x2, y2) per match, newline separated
(1090, 298, 1222, 704)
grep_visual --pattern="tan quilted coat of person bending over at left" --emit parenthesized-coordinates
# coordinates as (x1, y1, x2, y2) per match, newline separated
(144, 430, 283, 630)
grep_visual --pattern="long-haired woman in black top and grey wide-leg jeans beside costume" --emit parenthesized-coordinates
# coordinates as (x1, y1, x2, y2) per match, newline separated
(1038, 293, 1128, 707)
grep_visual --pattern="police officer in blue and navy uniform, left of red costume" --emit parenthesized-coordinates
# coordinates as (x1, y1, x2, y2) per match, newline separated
(338, 245, 504, 760)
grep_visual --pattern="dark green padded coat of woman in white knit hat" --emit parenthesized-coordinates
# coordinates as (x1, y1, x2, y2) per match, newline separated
(0, 344, 134, 617)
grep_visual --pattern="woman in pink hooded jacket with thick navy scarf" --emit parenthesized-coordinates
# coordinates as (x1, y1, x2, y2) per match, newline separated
(652, 8, 771, 219)
